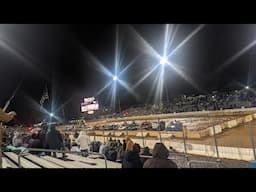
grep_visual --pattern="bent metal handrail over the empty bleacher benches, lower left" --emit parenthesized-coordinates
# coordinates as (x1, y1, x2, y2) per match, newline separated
(18, 148, 108, 168)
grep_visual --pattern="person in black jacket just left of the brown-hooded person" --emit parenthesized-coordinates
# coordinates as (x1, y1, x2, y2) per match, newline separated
(122, 143, 143, 168)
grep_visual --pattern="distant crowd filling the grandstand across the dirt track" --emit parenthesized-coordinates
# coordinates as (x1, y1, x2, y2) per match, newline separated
(88, 88, 256, 118)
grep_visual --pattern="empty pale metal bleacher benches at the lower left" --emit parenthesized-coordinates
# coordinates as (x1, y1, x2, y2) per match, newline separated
(3, 147, 121, 168)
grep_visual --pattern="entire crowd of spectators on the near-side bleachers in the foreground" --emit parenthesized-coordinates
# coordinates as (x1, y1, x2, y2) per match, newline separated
(2, 126, 177, 168)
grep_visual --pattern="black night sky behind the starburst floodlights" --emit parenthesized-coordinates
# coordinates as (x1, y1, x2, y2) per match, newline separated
(0, 24, 256, 123)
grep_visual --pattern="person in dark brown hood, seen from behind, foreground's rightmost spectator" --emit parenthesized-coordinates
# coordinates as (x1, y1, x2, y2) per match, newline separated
(143, 143, 178, 168)
